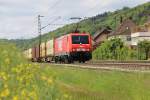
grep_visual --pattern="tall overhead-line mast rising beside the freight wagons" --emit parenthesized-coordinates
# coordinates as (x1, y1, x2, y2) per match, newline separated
(38, 15, 44, 59)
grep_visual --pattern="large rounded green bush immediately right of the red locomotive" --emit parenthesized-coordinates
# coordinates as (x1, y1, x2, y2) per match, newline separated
(93, 38, 137, 60)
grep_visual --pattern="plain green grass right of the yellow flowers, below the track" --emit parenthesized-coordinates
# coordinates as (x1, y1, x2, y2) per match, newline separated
(42, 66, 150, 100)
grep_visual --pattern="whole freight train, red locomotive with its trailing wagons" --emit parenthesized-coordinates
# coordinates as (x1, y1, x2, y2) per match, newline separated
(24, 33, 92, 63)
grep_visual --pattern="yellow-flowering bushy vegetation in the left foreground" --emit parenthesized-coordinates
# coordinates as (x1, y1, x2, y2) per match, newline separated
(0, 42, 63, 100)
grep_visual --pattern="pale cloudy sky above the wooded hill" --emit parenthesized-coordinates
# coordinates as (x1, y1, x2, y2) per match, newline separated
(0, 0, 150, 39)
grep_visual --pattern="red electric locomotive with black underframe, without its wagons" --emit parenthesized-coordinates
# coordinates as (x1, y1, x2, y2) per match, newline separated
(54, 33, 92, 63)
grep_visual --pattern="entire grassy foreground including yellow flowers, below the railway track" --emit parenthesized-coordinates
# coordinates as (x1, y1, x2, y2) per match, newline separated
(0, 43, 150, 100)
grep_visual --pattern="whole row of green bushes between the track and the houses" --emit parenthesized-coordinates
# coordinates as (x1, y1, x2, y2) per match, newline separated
(93, 38, 150, 61)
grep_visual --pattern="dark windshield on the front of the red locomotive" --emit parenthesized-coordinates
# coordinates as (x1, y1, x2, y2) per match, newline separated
(72, 35, 89, 44)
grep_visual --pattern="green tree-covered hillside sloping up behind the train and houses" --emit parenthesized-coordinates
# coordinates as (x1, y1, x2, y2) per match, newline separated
(12, 2, 150, 49)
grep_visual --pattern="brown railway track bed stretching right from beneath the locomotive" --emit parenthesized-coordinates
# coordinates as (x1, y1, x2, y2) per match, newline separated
(42, 62, 150, 73)
